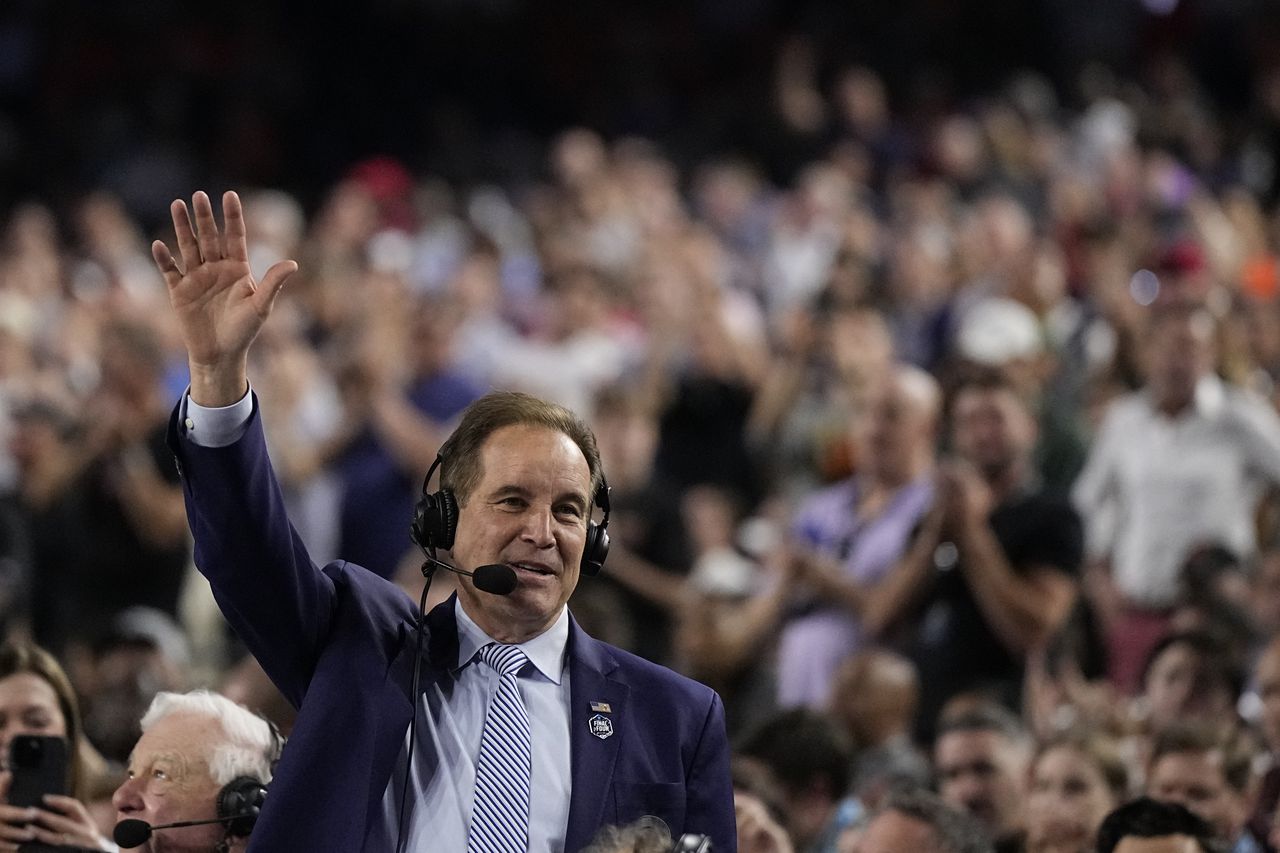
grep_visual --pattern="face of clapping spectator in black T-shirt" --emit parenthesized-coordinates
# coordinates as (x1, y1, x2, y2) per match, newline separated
(951, 388, 1036, 478)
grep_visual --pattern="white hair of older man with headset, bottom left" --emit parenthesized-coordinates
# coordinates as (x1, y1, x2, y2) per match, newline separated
(142, 690, 280, 785)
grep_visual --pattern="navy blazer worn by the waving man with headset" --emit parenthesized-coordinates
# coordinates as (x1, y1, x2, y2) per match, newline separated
(169, 400, 737, 853)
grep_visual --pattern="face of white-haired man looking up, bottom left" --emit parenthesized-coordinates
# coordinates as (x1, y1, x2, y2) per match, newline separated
(111, 712, 225, 853)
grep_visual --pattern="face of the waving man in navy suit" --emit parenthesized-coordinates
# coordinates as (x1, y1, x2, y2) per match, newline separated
(452, 424, 591, 643)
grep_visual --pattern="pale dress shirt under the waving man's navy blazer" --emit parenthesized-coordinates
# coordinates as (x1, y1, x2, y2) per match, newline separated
(179, 393, 571, 853)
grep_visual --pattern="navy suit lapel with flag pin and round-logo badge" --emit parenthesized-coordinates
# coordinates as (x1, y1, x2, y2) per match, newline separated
(564, 616, 630, 850)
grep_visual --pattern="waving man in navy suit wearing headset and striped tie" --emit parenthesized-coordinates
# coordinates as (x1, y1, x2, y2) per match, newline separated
(152, 192, 736, 853)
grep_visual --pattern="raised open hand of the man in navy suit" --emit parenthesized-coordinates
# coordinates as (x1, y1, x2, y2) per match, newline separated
(151, 192, 298, 406)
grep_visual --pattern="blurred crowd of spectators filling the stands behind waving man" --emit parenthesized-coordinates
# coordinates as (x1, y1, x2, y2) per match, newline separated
(10, 50, 1280, 853)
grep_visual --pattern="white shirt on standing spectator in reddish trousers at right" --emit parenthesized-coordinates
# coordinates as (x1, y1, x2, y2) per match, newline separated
(1073, 377, 1280, 608)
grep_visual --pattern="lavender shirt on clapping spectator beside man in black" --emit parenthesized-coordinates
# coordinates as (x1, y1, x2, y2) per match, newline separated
(778, 476, 933, 708)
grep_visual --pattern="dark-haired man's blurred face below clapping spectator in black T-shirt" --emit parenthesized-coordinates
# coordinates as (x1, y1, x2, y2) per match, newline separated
(934, 730, 1030, 840)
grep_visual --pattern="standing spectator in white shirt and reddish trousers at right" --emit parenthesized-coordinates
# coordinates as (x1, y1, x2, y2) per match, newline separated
(1074, 304, 1280, 690)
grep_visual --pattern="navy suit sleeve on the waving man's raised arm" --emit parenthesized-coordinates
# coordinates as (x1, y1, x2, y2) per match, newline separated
(169, 397, 334, 706)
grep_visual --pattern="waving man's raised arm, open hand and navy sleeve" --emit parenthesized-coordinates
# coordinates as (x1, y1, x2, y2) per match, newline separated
(152, 192, 345, 706)
